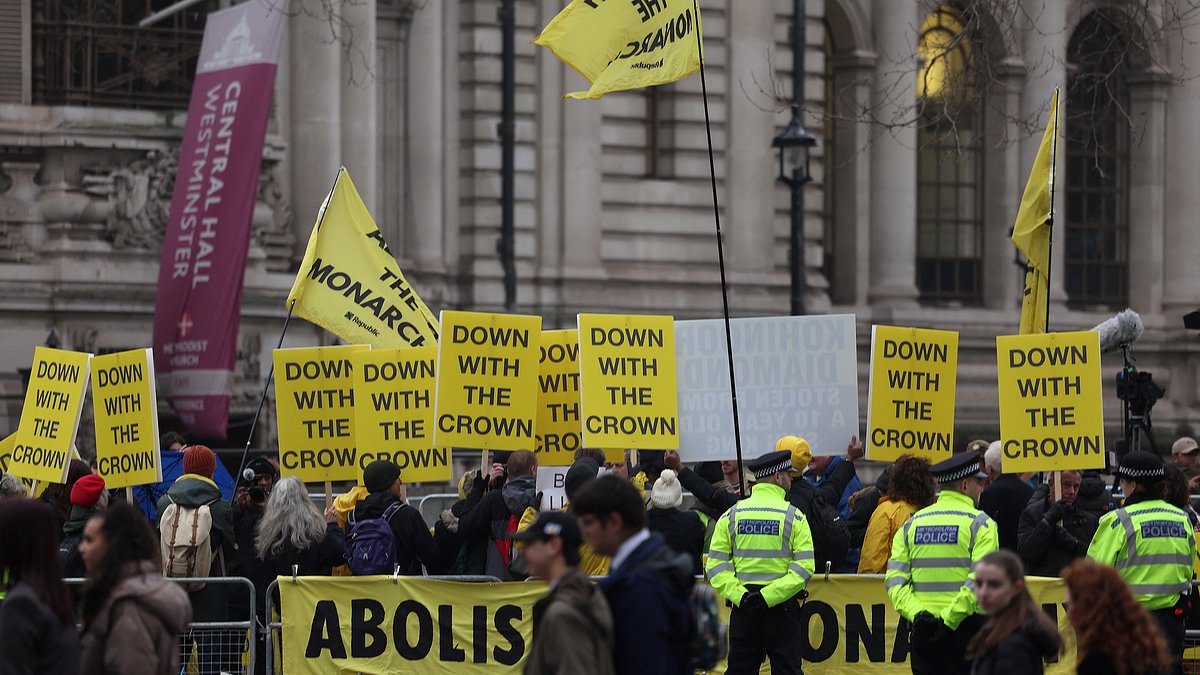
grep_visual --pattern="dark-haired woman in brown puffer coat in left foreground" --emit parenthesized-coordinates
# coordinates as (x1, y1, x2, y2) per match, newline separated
(79, 503, 192, 675)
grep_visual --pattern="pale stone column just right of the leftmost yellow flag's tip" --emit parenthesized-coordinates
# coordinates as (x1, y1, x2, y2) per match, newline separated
(340, 0, 380, 214)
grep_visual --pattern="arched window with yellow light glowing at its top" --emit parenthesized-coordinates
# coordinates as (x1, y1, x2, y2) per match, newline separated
(917, 5, 984, 304)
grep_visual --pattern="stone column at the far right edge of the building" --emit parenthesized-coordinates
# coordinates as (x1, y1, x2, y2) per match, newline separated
(1161, 24, 1200, 314)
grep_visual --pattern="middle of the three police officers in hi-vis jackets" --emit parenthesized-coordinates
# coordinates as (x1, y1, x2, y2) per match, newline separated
(884, 453, 997, 675)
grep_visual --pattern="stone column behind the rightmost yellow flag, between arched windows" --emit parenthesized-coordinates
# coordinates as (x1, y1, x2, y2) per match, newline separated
(1009, 0, 1070, 309)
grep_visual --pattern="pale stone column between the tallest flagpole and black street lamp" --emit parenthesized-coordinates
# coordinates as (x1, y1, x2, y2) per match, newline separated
(721, 2, 772, 274)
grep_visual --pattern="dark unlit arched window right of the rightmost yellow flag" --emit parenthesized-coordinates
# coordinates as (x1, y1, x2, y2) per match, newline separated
(1063, 12, 1129, 307)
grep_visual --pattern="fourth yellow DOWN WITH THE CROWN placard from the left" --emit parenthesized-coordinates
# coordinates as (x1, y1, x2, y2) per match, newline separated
(350, 346, 450, 483)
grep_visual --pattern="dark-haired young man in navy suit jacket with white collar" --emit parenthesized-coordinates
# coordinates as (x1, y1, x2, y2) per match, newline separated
(571, 476, 695, 675)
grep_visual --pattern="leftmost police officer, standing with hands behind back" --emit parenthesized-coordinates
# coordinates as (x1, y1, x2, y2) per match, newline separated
(706, 450, 815, 675)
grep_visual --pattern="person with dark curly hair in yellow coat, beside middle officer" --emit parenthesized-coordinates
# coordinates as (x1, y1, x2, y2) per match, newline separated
(858, 455, 937, 574)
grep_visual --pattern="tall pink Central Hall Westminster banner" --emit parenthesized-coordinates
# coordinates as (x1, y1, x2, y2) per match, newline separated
(154, 0, 287, 440)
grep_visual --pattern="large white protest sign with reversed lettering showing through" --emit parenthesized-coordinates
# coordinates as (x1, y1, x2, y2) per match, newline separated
(676, 315, 859, 461)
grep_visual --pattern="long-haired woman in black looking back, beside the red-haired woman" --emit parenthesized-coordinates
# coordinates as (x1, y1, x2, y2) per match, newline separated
(967, 550, 1062, 675)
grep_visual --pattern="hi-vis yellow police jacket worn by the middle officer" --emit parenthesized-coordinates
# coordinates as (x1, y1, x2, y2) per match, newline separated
(884, 489, 998, 629)
